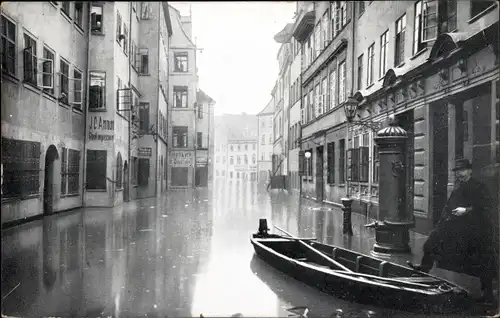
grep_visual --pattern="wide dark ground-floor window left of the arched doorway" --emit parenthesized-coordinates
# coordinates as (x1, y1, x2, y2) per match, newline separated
(2, 137, 40, 198)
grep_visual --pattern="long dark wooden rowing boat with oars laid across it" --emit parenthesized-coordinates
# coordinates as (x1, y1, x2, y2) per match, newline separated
(250, 219, 470, 312)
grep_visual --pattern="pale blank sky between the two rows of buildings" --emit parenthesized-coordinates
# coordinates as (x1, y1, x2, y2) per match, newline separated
(169, 1, 296, 115)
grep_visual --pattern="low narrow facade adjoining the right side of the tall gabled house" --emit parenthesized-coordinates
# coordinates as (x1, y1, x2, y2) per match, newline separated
(195, 89, 215, 187)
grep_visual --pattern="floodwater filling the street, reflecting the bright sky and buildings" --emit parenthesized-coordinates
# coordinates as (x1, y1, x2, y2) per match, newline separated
(2, 181, 456, 317)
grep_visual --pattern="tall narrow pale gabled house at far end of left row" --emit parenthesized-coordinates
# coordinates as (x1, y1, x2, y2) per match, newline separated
(168, 7, 198, 189)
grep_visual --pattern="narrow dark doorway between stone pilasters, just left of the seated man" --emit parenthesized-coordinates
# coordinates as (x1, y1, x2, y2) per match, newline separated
(430, 101, 448, 226)
